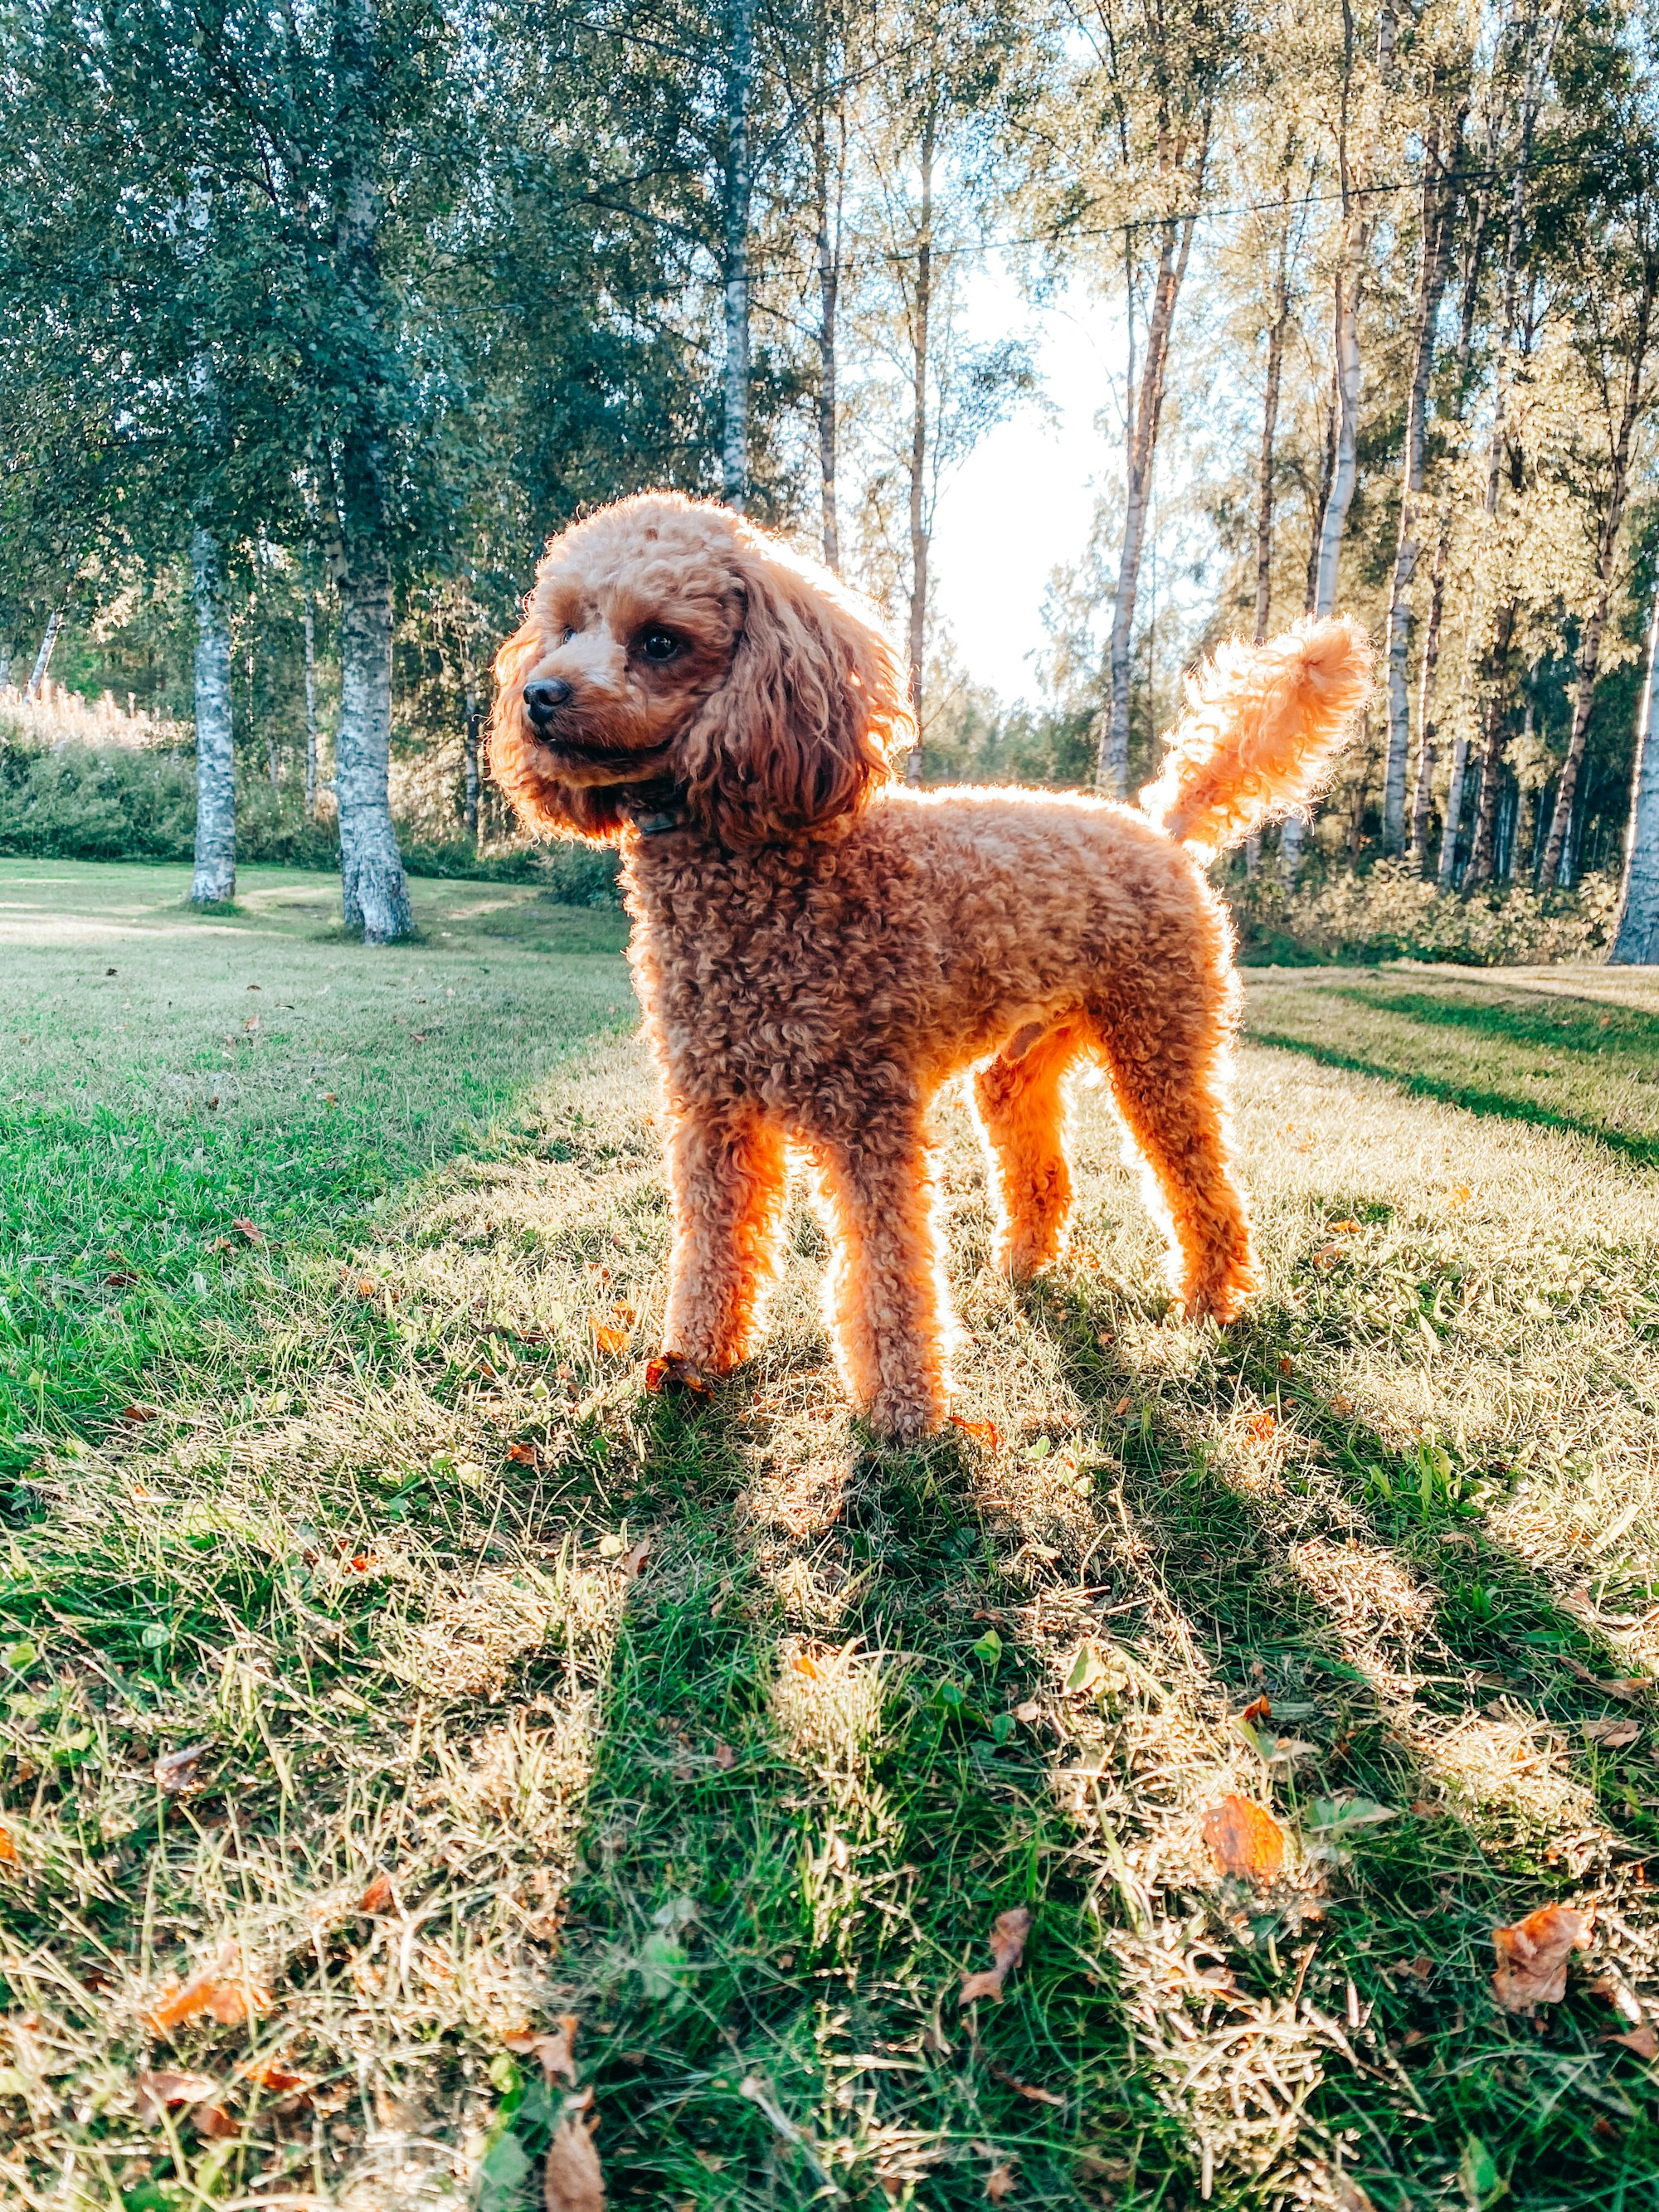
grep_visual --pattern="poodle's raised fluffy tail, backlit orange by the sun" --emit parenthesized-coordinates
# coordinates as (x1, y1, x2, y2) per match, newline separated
(1141, 615, 1371, 858)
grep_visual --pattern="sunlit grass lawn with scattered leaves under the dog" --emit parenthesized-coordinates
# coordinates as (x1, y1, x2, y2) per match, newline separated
(0, 863, 1659, 2212)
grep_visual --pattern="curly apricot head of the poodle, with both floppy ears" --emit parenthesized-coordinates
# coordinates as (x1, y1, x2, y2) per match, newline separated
(489, 491, 913, 847)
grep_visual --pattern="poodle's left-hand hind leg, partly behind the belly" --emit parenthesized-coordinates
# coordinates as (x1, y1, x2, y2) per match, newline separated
(973, 1019, 1086, 1283)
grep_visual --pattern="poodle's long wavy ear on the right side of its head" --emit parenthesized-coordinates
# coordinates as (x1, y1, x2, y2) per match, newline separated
(677, 531, 913, 847)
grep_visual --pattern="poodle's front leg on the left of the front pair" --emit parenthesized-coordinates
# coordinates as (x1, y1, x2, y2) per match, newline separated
(664, 1106, 787, 1376)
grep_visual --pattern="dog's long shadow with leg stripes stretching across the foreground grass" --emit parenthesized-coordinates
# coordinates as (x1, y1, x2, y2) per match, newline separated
(527, 1287, 1659, 2212)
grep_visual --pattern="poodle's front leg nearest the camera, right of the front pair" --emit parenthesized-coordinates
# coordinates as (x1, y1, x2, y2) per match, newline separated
(814, 1117, 949, 1442)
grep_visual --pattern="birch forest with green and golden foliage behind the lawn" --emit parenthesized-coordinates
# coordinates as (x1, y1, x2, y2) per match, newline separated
(0, 0, 1659, 960)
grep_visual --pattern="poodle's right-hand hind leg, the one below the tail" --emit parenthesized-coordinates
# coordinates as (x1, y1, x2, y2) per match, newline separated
(1091, 962, 1257, 1320)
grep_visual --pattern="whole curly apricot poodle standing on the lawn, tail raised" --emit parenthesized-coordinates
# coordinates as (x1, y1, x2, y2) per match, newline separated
(489, 493, 1370, 1440)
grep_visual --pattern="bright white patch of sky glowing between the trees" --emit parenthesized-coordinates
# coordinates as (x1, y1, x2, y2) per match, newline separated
(933, 265, 1121, 703)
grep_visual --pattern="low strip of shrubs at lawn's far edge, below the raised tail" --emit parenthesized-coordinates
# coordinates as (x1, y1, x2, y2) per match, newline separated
(1225, 860, 1619, 966)
